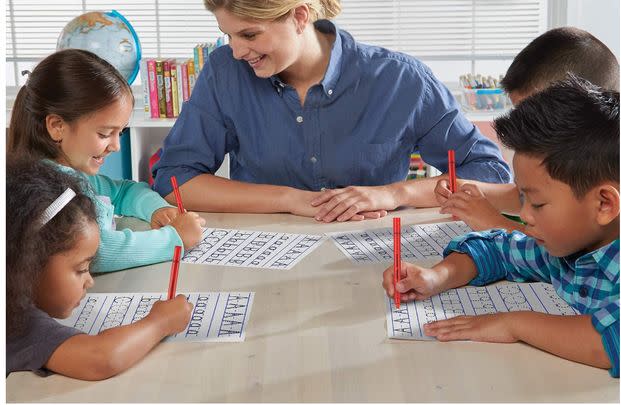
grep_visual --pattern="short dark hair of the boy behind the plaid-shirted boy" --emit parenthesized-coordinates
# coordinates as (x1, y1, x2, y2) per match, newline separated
(500, 27, 619, 94)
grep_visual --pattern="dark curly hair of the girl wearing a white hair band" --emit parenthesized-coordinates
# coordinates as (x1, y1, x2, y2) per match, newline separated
(6, 157, 97, 336)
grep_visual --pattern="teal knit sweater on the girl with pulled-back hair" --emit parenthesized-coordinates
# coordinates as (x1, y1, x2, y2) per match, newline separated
(49, 161, 183, 273)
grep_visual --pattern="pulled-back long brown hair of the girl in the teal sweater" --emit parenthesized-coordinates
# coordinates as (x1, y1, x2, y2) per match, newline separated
(7, 49, 134, 160)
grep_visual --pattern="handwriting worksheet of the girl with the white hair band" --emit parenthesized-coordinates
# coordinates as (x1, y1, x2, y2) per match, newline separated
(58, 292, 254, 342)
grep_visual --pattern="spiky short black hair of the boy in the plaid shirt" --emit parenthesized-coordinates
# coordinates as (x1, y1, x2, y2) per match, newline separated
(493, 75, 619, 198)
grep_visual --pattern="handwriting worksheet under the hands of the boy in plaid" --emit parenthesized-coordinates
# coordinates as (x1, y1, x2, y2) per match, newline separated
(386, 283, 578, 340)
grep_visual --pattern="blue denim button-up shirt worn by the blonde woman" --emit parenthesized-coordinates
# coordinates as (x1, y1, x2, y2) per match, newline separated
(153, 20, 511, 195)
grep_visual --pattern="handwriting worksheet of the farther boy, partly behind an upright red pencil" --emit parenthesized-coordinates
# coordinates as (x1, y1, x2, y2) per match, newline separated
(328, 221, 472, 263)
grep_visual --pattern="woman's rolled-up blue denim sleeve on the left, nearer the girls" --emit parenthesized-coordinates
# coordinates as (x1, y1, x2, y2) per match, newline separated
(153, 58, 234, 196)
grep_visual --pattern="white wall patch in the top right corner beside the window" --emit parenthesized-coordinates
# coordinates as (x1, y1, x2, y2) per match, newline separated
(567, 0, 620, 60)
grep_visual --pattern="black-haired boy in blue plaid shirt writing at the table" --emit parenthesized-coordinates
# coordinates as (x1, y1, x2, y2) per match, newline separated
(383, 76, 619, 378)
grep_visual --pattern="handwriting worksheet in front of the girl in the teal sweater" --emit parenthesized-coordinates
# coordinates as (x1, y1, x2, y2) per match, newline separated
(182, 228, 324, 270)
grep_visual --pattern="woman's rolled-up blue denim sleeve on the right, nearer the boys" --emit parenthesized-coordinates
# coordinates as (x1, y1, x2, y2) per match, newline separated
(417, 68, 512, 183)
